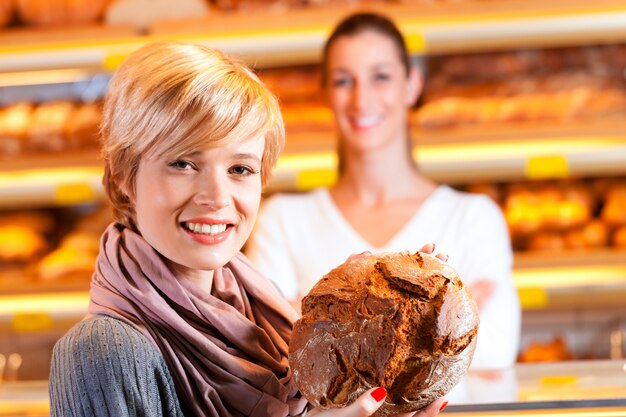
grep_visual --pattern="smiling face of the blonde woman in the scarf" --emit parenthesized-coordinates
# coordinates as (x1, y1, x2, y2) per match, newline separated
(134, 136, 265, 272)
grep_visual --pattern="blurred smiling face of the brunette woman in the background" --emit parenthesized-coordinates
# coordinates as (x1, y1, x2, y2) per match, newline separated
(326, 31, 421, 151)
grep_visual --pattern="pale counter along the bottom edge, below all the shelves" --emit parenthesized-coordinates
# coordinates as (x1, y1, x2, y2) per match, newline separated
(0, 357, 626, 417)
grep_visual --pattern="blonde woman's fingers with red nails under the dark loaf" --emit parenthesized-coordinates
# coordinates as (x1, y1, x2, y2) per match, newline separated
(307, 387, 448, 417)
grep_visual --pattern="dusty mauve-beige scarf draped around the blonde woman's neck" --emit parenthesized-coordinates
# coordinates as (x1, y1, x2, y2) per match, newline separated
(89, 225, 306, 417)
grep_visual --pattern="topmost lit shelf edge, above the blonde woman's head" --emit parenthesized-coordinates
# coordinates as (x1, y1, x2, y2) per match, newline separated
(0, 0, 626, 72)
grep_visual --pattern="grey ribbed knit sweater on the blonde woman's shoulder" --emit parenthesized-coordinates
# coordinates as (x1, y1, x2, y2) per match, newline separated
(48, 316, 184, 417)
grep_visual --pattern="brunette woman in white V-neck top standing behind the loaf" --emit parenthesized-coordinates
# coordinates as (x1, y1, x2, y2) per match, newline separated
(247, 13, 520, 369)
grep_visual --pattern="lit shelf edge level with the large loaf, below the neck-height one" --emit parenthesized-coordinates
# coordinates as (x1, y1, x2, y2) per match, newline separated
(0, 248, 626, 318)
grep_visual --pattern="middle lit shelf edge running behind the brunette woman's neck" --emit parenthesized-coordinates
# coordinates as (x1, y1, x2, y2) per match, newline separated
(0, 119, 626, 208)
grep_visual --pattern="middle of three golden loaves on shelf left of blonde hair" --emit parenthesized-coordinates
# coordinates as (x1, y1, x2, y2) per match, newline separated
(28, 100, 75, 152)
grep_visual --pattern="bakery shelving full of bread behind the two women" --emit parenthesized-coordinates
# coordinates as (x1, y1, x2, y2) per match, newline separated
(0, 0, 626, 416)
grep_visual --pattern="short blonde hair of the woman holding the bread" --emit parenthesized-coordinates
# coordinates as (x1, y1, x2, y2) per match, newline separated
(101, 42, 285, 229)
